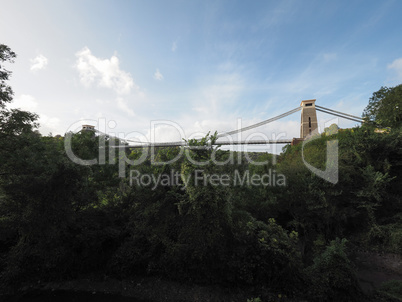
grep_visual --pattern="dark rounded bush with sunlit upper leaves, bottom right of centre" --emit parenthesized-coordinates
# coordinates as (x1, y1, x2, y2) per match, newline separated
(228, 219, 301, 294)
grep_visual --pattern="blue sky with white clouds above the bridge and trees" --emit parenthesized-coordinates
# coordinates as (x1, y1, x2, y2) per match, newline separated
(0, 0, 402, 150)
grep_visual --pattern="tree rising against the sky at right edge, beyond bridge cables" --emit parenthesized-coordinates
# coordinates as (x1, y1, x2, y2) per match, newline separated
(363, 84, 402, 128)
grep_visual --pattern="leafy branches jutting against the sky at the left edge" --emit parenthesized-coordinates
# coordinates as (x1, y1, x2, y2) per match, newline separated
(0, 44, 16, 108)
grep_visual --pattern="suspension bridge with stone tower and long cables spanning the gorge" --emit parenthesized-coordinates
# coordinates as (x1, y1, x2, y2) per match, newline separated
(81, 99, 364, 148)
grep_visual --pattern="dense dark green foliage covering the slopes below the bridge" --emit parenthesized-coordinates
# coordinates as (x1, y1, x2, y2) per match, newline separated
(0, 44, 402, 301)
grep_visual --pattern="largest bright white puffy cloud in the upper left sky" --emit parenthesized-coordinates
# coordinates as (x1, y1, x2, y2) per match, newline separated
(76, 47, 138, 94)
